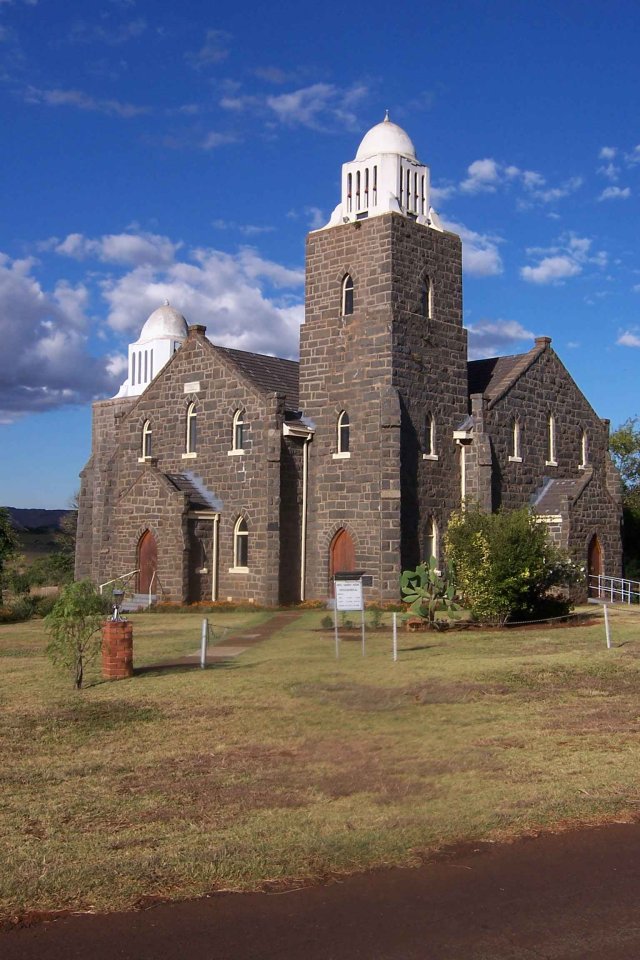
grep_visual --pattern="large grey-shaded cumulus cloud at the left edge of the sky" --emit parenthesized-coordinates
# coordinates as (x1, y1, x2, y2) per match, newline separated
(0, 254, 116, 423)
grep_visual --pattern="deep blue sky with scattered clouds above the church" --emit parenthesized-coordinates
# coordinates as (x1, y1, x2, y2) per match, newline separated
(0, 0, 640, 507)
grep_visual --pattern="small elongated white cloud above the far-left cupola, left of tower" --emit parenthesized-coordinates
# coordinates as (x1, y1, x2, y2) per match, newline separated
(54, 233, 182, 266)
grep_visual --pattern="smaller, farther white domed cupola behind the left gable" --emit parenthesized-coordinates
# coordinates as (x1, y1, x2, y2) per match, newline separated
(116, 300, 187, 397)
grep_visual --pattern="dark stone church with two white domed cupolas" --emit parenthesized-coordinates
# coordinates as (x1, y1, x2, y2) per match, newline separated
(76, 117, 621, 604)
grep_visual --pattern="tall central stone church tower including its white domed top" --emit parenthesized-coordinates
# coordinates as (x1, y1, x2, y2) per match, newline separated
(300, 116, 468, 599)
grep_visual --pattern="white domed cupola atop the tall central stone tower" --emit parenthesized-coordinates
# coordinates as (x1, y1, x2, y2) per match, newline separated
(322, 111, 442, 230)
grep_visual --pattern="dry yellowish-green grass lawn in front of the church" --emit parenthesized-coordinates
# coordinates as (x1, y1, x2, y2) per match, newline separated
(0, 608, 640, 919)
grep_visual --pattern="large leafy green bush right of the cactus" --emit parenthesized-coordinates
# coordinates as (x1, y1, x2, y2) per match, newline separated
(445, 506, 583, 623)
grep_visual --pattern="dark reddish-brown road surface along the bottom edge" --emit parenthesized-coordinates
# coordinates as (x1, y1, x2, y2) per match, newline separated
(5, 824, 640, 960)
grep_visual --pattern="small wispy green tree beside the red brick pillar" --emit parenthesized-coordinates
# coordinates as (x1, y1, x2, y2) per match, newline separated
(45, 580, 106, 690)
